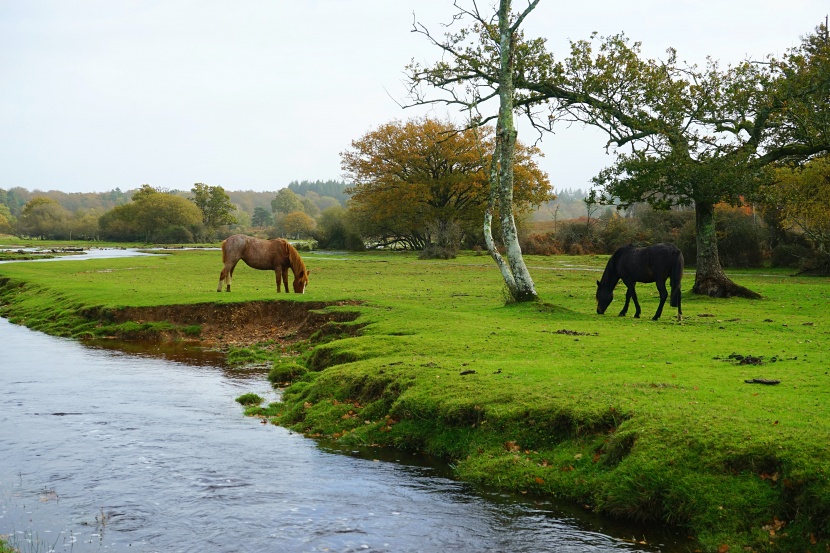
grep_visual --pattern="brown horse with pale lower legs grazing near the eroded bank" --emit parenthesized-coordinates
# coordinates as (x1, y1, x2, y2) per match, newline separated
(216, 234, 310, 294)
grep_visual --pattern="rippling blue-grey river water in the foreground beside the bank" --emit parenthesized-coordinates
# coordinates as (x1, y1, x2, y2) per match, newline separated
(0, 296, 681, 553)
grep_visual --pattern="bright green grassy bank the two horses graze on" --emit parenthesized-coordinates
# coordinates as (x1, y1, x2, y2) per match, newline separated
(0, 251, 830, 551)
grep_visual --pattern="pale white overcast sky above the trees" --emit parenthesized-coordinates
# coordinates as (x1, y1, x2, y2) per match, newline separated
(0, 0, 830, 192)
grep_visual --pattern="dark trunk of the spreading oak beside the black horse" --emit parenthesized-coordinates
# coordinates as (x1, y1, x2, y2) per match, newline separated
(692, 202, 761, 299)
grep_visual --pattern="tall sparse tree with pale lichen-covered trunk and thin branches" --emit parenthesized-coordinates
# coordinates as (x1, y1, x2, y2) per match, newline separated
(407, 0, 539, 301)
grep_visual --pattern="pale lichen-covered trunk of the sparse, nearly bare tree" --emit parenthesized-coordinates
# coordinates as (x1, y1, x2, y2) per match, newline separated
(484, 0, 536, 301)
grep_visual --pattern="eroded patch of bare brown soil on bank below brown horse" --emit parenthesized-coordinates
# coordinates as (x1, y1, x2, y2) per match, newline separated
(111, 301, 359, 346)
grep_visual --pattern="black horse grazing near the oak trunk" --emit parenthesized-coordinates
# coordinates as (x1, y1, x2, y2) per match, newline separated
(597, 244, 683, 321)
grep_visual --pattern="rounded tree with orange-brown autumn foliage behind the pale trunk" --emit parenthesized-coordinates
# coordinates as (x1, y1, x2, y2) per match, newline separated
(341, 118, 551, 250)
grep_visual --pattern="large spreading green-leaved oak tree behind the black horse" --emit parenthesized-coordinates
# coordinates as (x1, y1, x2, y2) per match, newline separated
(515, 27, 830, 297)
